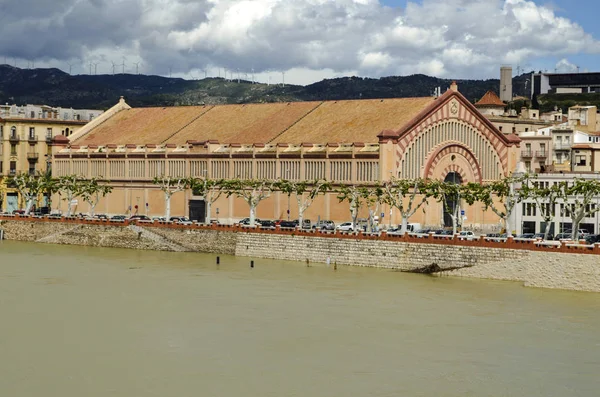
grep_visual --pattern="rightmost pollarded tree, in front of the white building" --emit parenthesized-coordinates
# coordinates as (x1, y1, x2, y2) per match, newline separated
(557, 178, 600, 240)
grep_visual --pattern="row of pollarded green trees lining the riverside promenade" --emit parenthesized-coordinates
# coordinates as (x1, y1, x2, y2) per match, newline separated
(8, 174, 600, 239)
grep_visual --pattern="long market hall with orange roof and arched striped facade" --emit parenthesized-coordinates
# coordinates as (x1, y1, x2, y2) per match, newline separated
(52, 84, 520, 226)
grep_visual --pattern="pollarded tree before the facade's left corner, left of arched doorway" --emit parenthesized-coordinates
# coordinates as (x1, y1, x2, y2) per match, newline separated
(383, 177, 440, 233)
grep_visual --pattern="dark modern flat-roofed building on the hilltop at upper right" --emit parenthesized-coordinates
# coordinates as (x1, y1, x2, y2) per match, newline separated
(531, 72, 600, 98)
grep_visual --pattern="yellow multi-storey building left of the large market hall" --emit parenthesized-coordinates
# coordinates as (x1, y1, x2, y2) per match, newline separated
(0, 105, 102, 212)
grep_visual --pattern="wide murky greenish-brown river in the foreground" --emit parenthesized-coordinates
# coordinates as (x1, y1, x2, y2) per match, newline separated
(0, 241, 600, 397)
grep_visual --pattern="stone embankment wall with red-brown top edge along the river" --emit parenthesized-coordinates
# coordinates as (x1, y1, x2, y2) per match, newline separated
(0, 218, 600, 292)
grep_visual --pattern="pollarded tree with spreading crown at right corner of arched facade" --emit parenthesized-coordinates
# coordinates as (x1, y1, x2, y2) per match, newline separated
(468, 175, 529, 236)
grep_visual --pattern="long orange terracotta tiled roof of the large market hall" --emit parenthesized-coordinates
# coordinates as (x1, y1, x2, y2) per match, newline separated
(72, 97, 435, 145)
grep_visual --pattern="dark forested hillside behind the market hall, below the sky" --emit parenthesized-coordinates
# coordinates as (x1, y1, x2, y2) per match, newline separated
(0, 65, 528, 109)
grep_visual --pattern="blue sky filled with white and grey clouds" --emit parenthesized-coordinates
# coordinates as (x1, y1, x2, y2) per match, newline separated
(0, 0, 600, 84)
